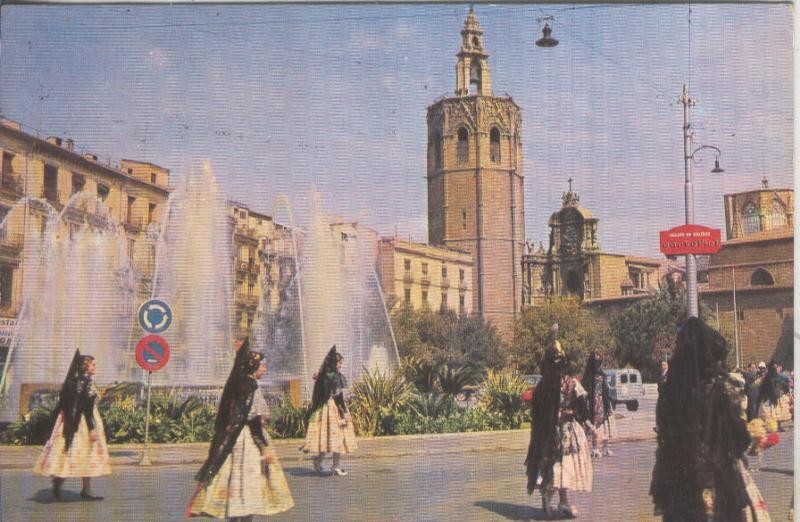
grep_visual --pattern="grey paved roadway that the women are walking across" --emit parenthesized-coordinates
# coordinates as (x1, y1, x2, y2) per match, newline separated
(0, 401, 794, 521)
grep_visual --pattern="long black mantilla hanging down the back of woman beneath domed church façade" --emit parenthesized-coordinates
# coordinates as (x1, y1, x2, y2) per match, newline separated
(525, 347, 563, 495)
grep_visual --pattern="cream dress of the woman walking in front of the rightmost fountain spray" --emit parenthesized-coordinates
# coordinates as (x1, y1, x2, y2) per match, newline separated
(302, 372, 358, 455)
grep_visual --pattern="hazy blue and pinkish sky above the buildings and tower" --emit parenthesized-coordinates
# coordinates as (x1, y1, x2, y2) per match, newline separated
(0, 4, 794, 257)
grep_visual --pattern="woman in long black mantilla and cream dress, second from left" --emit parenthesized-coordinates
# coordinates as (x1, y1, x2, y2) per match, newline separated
(186, 339, 294, 522)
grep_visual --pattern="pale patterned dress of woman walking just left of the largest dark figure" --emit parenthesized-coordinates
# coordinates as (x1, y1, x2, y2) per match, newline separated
(551, 376, 592, 491)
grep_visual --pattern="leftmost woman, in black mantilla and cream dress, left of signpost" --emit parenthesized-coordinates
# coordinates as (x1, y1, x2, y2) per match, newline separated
(33, 350, 111, 500)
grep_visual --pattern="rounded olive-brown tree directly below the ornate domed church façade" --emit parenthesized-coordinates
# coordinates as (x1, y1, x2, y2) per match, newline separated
(509, 297, 611, 375)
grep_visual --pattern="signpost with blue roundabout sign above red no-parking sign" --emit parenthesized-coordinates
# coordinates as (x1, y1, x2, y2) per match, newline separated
(136, 299, 172, 466)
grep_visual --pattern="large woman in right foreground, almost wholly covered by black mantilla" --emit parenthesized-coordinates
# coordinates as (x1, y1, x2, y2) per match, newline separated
(650, 317, 769, 522)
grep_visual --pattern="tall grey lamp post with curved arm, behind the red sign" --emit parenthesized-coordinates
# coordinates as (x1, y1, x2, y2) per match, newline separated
(678, 84, 725, 317)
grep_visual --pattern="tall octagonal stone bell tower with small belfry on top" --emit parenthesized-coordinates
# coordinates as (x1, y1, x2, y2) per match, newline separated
(427, 8, 525, 339)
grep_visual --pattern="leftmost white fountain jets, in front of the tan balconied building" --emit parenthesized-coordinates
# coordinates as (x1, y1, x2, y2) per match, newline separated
(0, 193, 139, 421)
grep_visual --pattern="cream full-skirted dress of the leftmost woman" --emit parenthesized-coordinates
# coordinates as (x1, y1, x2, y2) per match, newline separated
(33, 378, 111, 478)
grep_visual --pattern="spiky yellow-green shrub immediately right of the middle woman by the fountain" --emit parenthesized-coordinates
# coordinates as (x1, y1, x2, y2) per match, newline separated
(349, 370, 412, 436)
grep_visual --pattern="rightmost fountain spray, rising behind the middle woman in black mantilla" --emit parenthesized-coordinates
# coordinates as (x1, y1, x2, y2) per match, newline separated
(254, 192, 399, 399)
